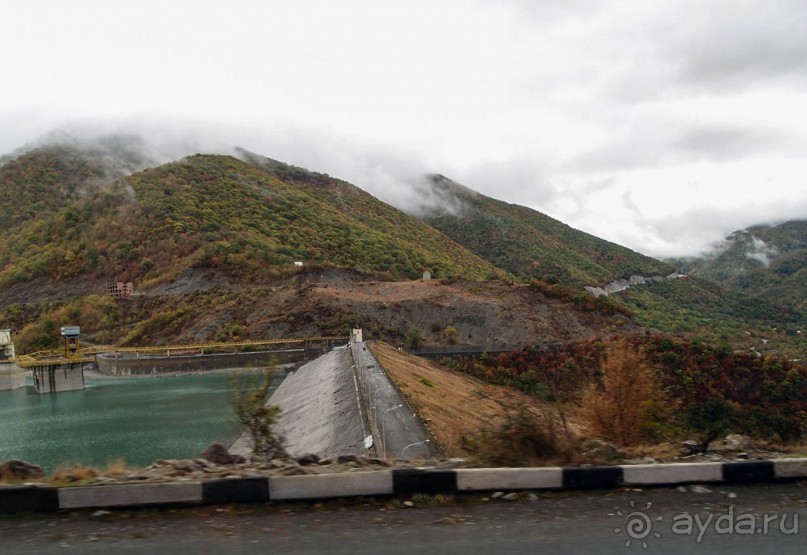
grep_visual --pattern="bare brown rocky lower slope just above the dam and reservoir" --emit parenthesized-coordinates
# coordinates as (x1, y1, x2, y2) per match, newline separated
(0, 270, 643, 352)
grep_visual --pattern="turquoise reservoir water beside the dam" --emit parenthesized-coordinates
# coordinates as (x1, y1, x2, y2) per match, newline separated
(0, 373, 281, 471)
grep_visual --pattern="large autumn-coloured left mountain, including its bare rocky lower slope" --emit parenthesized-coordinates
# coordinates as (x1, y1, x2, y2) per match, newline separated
(0, 140, 640, 352)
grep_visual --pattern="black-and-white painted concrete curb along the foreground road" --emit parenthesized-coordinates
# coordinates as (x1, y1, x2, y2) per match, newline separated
(0, 458, 807, 514)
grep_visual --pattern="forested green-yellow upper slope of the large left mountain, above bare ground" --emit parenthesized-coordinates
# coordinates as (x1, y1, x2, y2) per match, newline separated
(0, 152, 503, 286)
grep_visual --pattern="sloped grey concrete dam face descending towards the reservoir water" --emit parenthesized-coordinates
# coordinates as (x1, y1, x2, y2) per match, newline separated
(270, 351, 367, 457)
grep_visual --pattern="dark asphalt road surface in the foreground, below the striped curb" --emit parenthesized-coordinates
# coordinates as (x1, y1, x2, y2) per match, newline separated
(0, 483, 807, 555)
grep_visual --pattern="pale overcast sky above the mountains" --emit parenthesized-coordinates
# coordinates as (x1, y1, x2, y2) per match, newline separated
(0, 0, 807, 256)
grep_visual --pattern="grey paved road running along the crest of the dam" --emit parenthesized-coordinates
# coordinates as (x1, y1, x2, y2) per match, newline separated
(356, 342, 435, 459)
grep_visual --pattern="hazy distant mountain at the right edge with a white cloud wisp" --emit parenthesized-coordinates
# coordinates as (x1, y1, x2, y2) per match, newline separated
(670, 220, 807, 313)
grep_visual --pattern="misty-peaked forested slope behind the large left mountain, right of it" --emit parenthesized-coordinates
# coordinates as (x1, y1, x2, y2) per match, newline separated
(423, 175, 673, 287)
